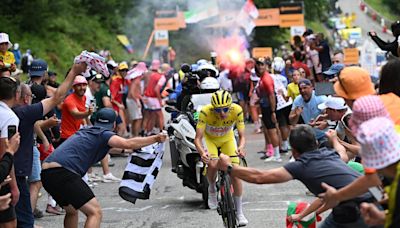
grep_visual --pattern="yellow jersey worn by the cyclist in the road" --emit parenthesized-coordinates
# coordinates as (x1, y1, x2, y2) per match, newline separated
(196, 104, 244, 139)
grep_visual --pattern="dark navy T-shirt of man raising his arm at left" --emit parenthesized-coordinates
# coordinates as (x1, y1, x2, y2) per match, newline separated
(13, 102, 43, 176)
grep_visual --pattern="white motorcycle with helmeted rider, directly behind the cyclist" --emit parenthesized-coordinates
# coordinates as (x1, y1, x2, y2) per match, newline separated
(165, 72, 219, 208)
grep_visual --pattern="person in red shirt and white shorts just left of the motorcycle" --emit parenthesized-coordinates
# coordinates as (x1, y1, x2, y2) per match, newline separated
(143, 60, 166, 133)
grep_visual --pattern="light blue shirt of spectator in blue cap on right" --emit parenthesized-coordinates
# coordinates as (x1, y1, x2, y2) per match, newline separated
(292, 91, 327, 139)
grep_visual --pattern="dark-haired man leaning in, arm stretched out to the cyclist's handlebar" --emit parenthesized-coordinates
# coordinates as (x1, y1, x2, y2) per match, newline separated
(218, 125, 372, 228)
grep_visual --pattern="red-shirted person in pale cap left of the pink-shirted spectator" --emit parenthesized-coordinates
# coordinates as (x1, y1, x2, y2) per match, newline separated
(110, 62, 129, 135)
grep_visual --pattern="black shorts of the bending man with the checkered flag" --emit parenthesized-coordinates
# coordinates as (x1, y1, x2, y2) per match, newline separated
(41, 167, 95, 209)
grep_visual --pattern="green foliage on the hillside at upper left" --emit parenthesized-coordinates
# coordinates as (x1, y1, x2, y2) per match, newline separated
(0, 0, 135, 78)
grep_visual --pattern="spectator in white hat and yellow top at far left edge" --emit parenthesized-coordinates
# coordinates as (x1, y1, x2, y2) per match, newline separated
(0, 33, 17, 76)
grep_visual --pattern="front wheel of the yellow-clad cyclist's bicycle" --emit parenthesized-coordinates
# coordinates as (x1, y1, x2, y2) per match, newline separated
(222, 174, 237, 228)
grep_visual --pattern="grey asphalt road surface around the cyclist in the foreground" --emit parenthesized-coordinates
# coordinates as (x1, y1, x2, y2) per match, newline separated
(36, 125, 313, 228)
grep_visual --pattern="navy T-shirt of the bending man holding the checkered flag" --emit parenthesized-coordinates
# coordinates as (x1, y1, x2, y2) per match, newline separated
(45, 126, 115, 177)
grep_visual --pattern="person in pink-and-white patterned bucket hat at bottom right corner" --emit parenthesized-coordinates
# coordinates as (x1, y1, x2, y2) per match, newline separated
(357, 117, 400, 228)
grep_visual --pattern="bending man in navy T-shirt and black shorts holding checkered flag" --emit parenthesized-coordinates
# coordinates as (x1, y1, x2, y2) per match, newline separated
(41, 108, 166, 228)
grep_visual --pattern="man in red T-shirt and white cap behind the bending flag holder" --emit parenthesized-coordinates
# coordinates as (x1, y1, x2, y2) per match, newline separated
(60, 75, 93, 144)
